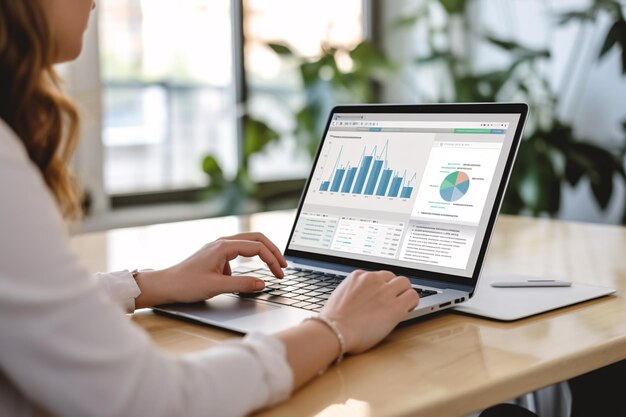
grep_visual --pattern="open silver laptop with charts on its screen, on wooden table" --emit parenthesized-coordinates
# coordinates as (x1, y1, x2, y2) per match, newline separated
(154, 103, 528, 333)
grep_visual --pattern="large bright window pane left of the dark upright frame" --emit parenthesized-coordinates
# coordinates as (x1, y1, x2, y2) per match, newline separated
(99, 0, 237, 194)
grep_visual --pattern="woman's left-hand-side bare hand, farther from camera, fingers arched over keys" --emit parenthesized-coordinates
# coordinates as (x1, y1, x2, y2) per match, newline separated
(135, 233, 287, 308)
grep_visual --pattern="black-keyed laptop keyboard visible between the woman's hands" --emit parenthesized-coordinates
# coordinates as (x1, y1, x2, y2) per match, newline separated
(233, 267, 437, 312)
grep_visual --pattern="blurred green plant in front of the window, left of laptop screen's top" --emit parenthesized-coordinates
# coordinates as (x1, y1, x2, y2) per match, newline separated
(202, 41, 395, 195)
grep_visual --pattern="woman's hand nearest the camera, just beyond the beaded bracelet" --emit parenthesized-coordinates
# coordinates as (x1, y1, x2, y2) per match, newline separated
(320, 270, 419, 353)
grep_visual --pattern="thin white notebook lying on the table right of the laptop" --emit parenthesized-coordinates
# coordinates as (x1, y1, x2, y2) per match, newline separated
(454, 274, 615, 321)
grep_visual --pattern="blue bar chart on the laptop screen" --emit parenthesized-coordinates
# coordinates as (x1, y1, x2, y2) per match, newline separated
(319, 141, 416, 199)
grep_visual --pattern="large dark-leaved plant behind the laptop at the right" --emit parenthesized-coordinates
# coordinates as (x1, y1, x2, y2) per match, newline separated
(397, 0, 626, 221)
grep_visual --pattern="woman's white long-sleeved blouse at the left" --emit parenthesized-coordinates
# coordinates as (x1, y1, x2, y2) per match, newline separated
(0, 120, 293, 417)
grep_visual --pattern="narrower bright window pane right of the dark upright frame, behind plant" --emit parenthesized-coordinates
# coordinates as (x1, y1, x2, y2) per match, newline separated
(244, 0, 364, 180)
